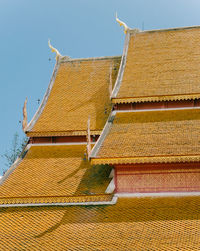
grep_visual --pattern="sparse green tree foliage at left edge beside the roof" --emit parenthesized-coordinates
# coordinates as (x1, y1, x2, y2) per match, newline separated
(1, 133, 28, 170)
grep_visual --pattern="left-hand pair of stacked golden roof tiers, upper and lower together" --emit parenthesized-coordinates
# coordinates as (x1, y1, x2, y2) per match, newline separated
(0, 56, 121, 206)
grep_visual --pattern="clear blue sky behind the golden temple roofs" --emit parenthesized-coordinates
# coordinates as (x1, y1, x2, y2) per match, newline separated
(0, 0, 200, 175)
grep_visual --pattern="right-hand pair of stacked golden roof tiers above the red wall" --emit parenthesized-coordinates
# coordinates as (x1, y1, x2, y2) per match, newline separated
(91, 27, 200, 164)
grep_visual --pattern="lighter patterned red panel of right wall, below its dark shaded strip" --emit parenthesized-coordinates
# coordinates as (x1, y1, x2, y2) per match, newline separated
(117, 170, 200, 193)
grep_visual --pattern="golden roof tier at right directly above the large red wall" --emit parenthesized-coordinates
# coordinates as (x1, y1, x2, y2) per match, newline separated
(91, 109, 200, 164)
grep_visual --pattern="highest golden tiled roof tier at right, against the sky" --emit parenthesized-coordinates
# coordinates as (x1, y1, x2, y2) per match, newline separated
(112, 26, 200, 103)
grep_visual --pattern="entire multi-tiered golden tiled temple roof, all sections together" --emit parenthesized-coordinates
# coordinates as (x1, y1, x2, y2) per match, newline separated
(0, 23, 200, 250)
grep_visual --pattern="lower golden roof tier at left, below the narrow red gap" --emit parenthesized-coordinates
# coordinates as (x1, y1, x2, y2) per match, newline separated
(0, 145, 111, 205)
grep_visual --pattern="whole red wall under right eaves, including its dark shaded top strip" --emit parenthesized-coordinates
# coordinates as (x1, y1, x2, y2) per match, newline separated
(115, 163, 200, 193)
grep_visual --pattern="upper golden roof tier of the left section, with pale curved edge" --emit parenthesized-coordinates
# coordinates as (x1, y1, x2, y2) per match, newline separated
(27, 57, 120, 136)
